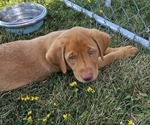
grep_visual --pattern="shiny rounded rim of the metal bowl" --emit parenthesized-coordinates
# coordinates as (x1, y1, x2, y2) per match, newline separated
(0, 2, 47, 28)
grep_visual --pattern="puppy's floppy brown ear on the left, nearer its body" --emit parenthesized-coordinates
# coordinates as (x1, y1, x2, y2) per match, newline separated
(46, 39, 67, 73)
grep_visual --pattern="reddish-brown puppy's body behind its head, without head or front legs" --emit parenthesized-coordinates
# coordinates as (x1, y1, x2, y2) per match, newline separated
(0, 31, 64, 91)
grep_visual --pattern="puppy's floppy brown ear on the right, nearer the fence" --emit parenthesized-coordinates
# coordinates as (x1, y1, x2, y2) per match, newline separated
(89, 29, 111, 60)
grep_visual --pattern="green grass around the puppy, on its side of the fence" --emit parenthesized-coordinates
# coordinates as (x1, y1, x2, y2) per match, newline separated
(0, 1, 150, 125)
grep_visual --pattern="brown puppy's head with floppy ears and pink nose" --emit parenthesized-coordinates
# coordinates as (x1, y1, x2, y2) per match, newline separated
(46, 27, 110, 82)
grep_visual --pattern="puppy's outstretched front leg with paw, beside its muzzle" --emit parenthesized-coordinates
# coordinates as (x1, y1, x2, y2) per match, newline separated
(98, 46, 138, 69)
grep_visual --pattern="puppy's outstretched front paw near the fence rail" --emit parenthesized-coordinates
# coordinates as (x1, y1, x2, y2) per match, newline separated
(120, 46, 138, 57)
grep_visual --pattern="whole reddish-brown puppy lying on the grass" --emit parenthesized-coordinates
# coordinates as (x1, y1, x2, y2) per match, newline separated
(0, 27, 137, 91)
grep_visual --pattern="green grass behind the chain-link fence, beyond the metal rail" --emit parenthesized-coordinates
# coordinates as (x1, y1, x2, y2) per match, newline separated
(71, 0, 150, 40)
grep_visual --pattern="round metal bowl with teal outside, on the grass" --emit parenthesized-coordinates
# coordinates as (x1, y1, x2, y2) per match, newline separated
(0, 2, 47, 34)
